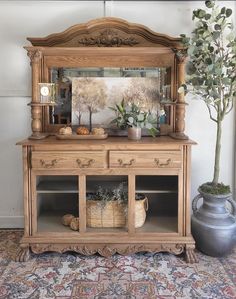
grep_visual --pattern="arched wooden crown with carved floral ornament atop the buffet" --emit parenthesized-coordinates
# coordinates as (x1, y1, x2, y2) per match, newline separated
(27, 18, 183, 49)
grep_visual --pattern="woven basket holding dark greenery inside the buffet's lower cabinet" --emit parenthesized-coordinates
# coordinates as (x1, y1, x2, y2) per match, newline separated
(86, 182, 148, 228)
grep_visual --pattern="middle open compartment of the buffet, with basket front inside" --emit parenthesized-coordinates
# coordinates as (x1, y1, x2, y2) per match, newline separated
(86, 175, 128, 233)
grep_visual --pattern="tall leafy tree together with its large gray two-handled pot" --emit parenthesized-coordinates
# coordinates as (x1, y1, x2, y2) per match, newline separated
(179, 1, 236, 256)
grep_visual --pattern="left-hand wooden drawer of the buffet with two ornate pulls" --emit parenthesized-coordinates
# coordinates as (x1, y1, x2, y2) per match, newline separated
(32, 151, 107, 169)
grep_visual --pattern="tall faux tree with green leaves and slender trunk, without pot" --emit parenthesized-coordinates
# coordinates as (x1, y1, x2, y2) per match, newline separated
(179, 1, 236, 193)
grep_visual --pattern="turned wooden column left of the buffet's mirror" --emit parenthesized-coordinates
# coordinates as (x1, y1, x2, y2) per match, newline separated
(28, 49, 45, 139)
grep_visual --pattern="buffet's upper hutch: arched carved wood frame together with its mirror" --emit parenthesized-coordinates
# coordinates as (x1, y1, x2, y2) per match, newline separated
(25, 18, 185, 138)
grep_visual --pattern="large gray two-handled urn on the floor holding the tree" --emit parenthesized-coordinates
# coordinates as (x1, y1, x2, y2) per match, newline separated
(192, 189, 236, 256)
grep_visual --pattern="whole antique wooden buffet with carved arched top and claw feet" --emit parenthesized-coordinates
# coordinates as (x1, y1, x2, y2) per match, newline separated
(18, 18, 196, 262)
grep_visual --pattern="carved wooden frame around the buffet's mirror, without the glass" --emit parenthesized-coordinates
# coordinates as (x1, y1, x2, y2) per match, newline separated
(25, 18, 187, 139)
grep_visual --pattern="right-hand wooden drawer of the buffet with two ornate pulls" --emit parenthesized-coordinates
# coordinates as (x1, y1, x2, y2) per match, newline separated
(109, 151, 182, 168)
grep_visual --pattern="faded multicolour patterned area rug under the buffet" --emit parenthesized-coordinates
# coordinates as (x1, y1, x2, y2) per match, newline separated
(0, 230, 236, 299)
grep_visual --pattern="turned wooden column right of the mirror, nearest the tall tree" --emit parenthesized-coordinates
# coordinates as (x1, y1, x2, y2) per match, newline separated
(170, 49, 188, 139)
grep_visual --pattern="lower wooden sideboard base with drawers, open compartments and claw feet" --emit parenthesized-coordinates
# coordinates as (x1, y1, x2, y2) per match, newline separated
(18, 136, 196, 262)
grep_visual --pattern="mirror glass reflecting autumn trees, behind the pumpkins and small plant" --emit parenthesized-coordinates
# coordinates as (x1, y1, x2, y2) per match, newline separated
(49, 67, 171, 129)
